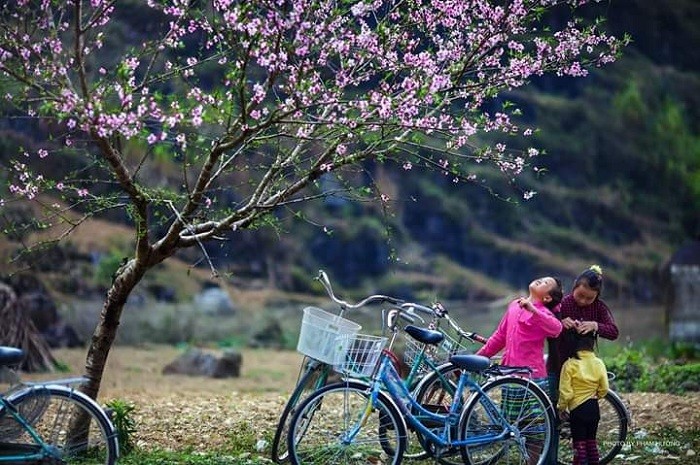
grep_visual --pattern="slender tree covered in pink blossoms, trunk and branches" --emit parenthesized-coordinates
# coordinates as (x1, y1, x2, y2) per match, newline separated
(0, 0, 626, 397)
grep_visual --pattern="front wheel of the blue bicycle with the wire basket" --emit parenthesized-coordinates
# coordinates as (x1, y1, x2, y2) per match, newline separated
(287, 381, 406, 465)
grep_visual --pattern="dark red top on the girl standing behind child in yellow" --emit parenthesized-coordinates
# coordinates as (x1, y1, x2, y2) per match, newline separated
(547, 294, 620, 376)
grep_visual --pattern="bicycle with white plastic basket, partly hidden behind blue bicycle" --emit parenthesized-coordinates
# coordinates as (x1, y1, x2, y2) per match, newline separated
(270, 270, 403, 463)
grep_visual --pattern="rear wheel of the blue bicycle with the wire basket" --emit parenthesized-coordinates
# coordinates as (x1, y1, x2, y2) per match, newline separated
(460, 376, 555, 465)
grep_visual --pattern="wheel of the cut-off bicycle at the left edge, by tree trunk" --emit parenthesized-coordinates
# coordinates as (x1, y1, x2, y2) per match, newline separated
(3, 385, 119, 465)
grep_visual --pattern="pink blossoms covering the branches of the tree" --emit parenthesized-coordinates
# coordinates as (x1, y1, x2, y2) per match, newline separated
(0, 0, 625, 229)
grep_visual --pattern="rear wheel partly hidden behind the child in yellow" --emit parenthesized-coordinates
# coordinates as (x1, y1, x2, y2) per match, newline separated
(557, 391, 629, 465)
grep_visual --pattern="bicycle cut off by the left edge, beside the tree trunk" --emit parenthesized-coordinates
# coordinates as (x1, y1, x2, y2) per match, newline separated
(0, 346, 119, 465)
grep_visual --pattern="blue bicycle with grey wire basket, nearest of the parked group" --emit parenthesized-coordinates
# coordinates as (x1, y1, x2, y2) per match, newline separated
(287, 309, 554, 465)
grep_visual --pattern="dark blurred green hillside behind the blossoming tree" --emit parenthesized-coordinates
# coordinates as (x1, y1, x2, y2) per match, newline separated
(0, 0, 700, 308)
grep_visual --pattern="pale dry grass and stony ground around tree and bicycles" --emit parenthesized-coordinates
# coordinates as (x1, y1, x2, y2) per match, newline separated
(13, 345, 700, 465)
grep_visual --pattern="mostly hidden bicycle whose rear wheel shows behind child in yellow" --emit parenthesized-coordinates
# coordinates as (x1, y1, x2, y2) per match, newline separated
(412, 303, 630, 465)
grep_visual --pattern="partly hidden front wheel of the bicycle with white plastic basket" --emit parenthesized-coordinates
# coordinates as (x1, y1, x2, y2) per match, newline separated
(270, 359, 330, 463)
